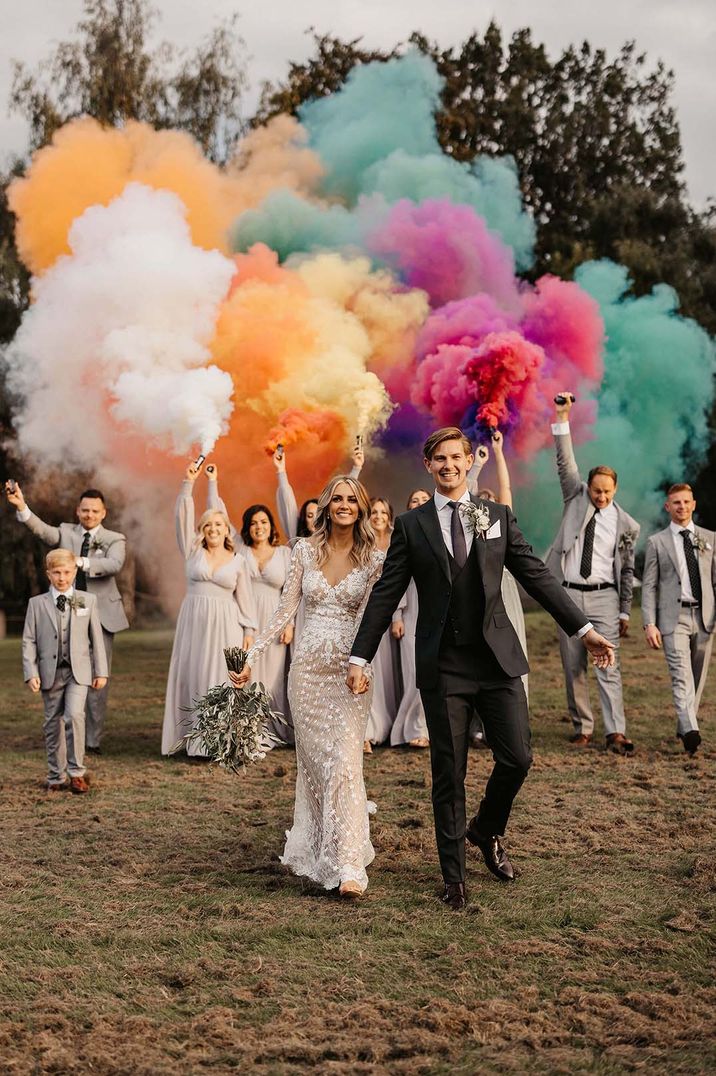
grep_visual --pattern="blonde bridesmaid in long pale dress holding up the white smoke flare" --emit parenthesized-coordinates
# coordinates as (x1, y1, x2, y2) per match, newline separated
(162, 464, 258, 755)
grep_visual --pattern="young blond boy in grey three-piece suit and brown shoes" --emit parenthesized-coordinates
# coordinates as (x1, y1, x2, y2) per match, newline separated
(23, 549, 108, 794)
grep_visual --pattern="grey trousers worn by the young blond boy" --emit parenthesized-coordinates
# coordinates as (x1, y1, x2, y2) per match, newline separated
(42, 666, 87, 784)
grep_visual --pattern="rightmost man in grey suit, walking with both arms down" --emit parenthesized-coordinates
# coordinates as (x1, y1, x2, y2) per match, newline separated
(642, 482, 716, 755)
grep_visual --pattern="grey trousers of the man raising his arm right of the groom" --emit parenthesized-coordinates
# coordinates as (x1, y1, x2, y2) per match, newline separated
(560, 589, 627, 736)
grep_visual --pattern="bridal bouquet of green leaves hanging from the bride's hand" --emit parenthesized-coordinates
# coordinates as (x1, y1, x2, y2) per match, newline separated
(172, 647, 286, 774)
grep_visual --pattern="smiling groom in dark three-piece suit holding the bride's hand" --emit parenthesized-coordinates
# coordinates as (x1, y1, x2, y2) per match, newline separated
(347, 426, 614, 910)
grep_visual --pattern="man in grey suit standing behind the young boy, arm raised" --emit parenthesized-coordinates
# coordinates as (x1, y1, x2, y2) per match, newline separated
(5, 482, 129, 754)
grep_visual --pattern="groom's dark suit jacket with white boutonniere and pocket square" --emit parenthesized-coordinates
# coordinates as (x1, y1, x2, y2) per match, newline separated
(351, 497, 587, 689)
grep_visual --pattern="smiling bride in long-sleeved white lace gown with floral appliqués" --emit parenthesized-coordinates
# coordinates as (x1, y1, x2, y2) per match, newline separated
(231, 476, 384, 897)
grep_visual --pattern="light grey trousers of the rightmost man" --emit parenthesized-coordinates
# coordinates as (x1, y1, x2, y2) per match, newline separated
(661, 608, 714, 736)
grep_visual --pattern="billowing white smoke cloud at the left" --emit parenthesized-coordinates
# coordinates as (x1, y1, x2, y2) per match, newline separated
(6, 184, 234, 469)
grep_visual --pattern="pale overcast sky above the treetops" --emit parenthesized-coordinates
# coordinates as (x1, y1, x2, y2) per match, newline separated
(0, 0, 716, 208)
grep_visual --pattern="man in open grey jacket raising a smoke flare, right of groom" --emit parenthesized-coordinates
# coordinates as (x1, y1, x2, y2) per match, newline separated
(545, 393, 640, 754)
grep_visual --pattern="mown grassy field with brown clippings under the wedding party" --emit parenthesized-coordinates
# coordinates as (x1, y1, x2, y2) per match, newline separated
(0, 614, 716, 1076)
